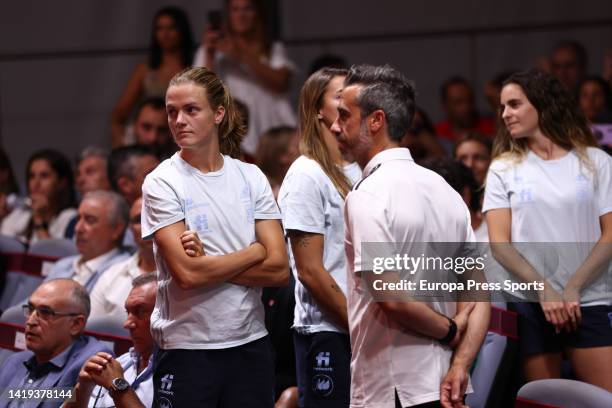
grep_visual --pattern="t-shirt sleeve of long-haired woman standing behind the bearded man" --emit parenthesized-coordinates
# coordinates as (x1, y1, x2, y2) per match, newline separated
(279, 172, 325, 234)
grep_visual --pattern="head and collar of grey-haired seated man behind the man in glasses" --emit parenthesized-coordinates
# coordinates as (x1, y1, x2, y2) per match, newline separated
(47, 190, 129, 292)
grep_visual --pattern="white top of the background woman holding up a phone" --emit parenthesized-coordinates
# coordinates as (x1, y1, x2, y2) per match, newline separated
(193, 42, 296, 154)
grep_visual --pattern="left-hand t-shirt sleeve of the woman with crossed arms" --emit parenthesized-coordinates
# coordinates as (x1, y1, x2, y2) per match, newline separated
(141, 171, 185, 239)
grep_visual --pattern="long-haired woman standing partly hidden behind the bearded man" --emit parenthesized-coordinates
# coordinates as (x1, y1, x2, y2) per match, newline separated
(278, 68, 360, 407)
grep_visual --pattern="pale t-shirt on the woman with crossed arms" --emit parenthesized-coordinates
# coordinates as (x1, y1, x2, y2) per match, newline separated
(142, 153, 281, 349)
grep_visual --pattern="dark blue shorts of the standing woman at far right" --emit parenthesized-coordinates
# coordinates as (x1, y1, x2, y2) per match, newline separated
(513, 302, 612, 356)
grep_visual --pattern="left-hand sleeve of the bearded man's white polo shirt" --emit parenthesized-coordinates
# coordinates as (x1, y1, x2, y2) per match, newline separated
(345, 190, 394, 272)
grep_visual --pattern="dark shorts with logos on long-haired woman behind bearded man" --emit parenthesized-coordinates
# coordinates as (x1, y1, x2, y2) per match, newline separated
(293, 332, 351, 408)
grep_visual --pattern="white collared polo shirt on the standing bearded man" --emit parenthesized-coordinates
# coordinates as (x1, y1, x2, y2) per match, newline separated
(345, 148, 474, 408)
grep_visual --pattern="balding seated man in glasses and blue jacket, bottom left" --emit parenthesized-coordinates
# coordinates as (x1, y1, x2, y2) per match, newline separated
(0, 279, 109, 408)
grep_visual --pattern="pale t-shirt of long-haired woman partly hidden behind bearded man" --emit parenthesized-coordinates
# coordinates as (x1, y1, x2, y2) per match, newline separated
(278, 156, 359, 334)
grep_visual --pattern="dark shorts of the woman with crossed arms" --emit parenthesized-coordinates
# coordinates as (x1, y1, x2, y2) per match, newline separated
(153, 336, 274, 408)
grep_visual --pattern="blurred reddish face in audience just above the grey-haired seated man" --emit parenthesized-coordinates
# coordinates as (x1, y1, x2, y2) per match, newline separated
(75, 146, 110, 197)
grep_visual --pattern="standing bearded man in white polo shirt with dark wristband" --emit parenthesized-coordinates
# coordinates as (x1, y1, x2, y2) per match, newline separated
(334, 65, 489, 408)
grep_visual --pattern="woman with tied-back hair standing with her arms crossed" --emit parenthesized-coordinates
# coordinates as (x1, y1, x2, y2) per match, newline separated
(142, 68, 289, 407)
